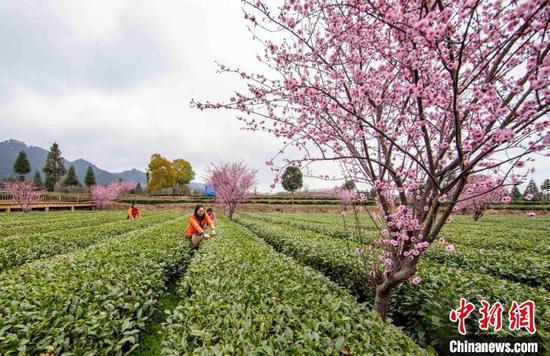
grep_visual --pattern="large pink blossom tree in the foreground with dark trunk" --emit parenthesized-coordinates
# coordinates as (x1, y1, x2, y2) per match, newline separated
(192, 0, 550, 319)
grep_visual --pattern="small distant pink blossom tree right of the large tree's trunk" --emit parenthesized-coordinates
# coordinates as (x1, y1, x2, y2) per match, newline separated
(454, 175, 512, 221)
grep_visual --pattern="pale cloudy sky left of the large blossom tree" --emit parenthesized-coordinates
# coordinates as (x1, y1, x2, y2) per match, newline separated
(0, 0, 550, 191)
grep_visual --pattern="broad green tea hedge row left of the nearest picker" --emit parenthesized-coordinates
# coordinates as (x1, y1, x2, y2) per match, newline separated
(0, 220, 189, 355)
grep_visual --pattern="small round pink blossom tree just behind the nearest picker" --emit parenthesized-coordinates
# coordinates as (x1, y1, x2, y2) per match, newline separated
(208, 163, 257, 219)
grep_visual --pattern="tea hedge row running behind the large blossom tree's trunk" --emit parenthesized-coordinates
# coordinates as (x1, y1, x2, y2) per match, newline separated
(237, 217, 550, 345)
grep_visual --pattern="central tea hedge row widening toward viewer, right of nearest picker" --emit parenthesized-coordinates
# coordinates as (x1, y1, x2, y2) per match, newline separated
(163, 219, 421, 355)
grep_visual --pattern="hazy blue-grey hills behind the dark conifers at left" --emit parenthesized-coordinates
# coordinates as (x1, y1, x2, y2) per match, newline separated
(0, 139, 145, 187)
